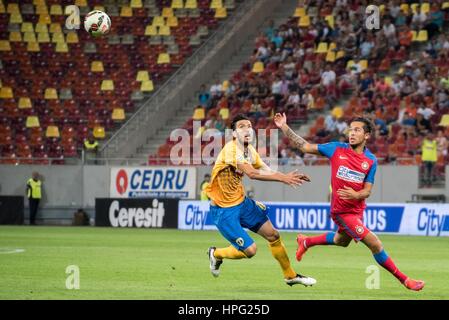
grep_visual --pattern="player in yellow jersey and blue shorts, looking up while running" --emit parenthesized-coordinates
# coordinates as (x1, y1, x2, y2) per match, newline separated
(206, 115, 316, 286)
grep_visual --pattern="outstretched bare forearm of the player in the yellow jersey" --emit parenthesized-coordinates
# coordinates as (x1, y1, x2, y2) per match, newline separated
(237, 163, 310, 187)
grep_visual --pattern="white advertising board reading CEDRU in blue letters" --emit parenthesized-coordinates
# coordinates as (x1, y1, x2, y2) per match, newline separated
(110, 167, 196, 199)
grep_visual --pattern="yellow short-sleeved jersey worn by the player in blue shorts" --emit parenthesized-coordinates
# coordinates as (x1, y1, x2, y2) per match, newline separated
(206, 140, 265, 208)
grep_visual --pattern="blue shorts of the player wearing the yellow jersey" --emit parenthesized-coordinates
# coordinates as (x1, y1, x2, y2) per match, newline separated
(209, 198, 268, 251)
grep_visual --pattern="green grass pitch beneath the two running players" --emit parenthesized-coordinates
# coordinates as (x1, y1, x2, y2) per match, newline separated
(0, 226, 449, 300)
